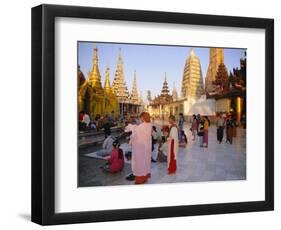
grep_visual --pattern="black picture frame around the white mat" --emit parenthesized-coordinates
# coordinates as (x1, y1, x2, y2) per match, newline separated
(31, 5, 274, 225)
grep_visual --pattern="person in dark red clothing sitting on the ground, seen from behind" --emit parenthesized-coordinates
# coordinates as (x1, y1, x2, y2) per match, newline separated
(103, 140, 124, 173)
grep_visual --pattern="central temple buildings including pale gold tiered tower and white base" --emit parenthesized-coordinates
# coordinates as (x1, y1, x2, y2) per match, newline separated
(148, 49, 215, 118)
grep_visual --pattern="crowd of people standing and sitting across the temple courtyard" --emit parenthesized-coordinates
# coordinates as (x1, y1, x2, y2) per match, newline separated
(86, 109, 241, 184)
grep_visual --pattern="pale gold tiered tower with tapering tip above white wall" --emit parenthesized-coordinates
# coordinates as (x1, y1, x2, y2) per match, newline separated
(181, 49, 204, 98)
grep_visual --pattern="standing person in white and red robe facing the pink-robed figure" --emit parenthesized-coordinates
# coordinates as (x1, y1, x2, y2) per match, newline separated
(167, 115, 179, 174)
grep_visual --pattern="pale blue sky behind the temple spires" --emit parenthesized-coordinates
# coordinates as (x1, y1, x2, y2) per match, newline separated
(78, 42, 245, 97)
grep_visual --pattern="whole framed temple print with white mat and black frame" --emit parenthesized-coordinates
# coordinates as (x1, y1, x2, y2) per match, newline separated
(32, 5, 274, 225)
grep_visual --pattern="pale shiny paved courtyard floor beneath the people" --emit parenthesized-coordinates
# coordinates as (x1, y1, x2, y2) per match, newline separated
(78, 124, 246, 187)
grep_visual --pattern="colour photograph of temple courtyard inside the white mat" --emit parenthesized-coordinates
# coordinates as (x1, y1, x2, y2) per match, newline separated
(76, 41, 247, 187)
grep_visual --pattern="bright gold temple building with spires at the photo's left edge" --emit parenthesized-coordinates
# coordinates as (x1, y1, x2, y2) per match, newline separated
(77, 47, 118, 119)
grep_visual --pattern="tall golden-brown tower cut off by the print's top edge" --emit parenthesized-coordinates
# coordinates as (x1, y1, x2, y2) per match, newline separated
(205, 48, 224, 93)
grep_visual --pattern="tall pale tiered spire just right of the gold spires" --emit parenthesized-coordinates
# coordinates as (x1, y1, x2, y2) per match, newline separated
(112, 49, 129, 102)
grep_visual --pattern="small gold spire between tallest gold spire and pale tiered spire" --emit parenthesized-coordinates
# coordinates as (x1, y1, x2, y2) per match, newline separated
(104, 67, 118, 114)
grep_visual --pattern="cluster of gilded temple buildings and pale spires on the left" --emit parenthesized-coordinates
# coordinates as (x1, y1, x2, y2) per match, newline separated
(77, 47, 142, 119)
